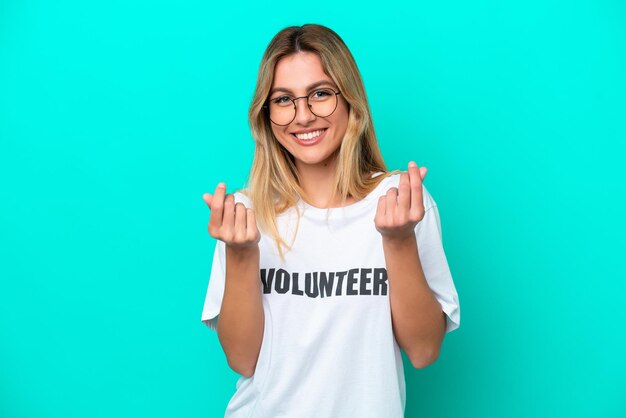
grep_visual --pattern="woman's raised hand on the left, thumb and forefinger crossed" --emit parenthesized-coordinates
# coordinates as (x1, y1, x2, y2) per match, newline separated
(202, 183, 261, 249)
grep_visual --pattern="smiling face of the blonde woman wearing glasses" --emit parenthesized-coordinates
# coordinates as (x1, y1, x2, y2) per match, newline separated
(269, 52, 349, 170)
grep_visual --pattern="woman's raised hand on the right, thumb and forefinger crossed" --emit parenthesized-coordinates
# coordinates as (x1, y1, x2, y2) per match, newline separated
(374, 161, 428, 240)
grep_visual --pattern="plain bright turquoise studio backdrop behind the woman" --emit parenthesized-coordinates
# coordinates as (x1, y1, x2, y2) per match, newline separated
(0, 0, 626, 418)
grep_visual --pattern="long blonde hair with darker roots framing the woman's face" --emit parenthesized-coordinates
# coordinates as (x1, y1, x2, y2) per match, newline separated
(243, 24, 392, 257)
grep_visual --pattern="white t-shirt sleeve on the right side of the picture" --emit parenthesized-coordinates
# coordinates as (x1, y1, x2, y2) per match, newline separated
(415, 186, 461, 333)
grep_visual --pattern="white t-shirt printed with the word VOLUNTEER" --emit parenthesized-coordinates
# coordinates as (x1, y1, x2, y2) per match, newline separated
(202, 174, 460, 418)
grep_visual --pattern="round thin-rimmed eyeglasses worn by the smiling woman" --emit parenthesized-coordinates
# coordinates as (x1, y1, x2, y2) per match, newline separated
(263, 88, 341, 126)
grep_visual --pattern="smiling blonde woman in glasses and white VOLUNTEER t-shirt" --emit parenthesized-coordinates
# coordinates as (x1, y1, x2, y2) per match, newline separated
(202, 24, 460, 418)
